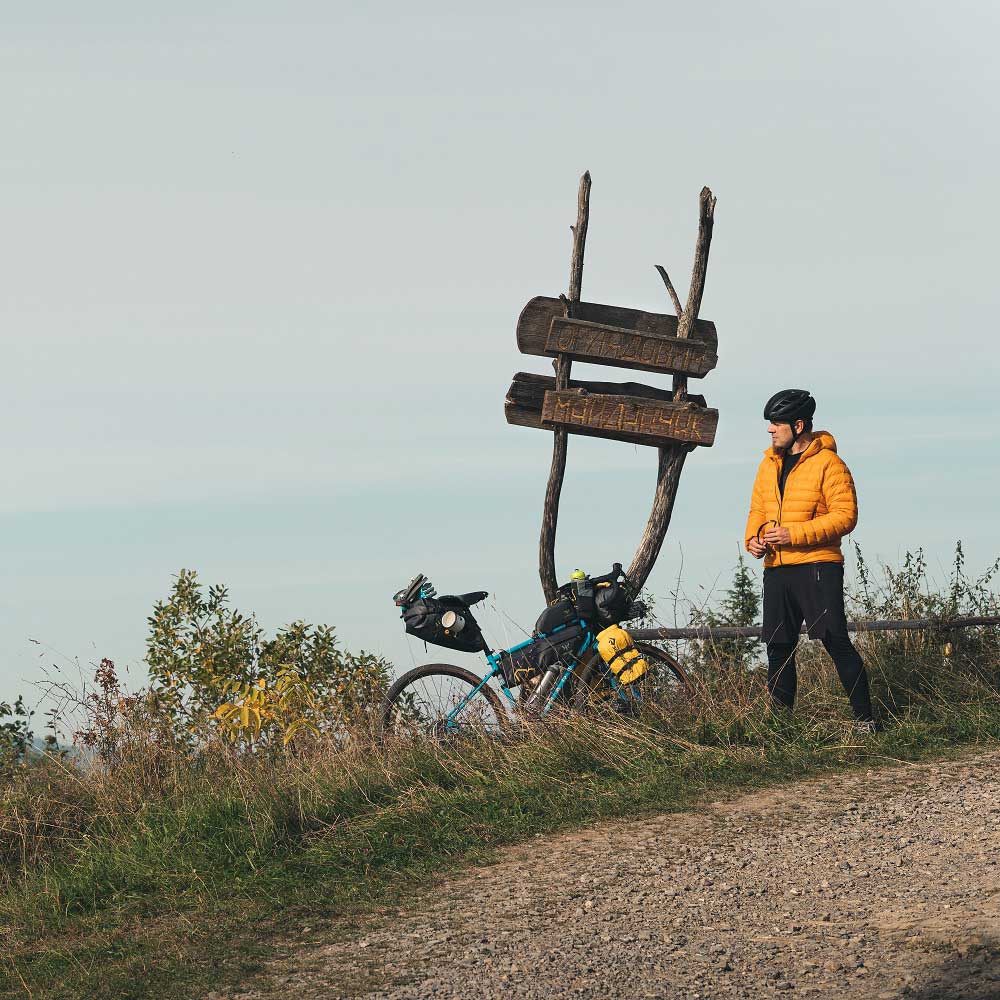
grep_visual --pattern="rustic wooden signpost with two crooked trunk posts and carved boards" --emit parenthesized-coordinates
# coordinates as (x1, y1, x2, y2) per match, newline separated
(504, 173, 719, 601)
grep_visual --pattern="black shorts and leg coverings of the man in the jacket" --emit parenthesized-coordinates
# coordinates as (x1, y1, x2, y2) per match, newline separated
(763, 563, 873, 720)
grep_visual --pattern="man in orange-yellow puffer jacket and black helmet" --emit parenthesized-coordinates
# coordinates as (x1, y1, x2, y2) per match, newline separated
(744, 389, 874, 731)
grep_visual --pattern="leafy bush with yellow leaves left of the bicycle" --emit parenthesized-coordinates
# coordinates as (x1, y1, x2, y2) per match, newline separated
(146, 570, 389, 748)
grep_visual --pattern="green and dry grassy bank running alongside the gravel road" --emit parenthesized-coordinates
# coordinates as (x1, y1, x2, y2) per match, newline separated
(0, 552, 1000, 1000)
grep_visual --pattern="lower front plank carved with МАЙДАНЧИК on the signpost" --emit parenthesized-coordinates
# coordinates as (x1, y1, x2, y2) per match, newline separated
(542, 389, 719, 448)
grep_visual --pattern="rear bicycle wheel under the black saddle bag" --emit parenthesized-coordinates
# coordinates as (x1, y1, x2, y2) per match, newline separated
(381, 663, 509, 739)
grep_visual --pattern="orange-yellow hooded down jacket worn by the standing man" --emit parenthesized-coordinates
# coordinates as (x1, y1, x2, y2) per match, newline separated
(744, 431, 858, 567)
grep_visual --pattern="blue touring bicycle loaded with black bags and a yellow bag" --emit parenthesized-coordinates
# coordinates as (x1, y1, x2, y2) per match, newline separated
(381, 563, 688, 737)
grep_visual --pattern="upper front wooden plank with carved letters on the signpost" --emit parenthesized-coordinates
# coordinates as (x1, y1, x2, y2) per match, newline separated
(545, 316, 719, 378)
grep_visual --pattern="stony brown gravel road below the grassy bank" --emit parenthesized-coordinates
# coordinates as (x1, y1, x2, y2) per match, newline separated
(225, 752, 1000, 1000)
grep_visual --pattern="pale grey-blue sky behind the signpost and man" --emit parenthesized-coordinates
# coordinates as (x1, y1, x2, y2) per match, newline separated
(0, 0, 1000, 716)
